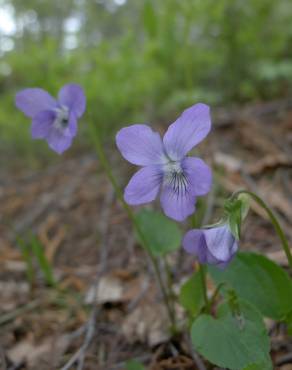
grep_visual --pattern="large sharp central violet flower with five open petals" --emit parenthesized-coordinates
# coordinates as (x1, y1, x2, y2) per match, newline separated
(116, 103, 212, 221)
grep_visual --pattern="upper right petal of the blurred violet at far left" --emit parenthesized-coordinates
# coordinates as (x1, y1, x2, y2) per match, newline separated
(58, 84, 86, 118)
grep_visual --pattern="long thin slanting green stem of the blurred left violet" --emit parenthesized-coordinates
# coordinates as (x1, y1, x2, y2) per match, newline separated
(92, 127, 177, 333)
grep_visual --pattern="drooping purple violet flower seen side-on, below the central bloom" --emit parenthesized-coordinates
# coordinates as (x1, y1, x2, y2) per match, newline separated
(183, 224, 238, 269)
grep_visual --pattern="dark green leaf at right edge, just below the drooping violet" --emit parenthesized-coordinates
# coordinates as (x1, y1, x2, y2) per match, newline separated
(209, 253, 292, 320)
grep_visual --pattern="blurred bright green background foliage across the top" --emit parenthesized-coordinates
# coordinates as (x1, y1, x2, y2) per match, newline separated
(0, 0, 292, 162)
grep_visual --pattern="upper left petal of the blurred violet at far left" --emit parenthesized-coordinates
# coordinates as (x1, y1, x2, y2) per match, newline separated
(15, 88, 57, 118)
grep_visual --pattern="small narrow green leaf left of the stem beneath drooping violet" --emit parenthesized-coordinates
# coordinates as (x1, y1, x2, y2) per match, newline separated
(179, 273, 204, 316)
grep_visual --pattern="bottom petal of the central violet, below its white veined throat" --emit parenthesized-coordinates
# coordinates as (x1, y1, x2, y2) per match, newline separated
(160, 184, 196, 221)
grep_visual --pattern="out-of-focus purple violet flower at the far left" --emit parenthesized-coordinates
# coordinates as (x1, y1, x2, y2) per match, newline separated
(15, 84, 86, 154)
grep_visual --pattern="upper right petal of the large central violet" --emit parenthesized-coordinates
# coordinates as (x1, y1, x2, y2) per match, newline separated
(163, 103, 211, 161)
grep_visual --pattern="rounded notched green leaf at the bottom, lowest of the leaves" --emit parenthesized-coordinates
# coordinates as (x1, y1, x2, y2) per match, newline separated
(191, 301, 272, 370)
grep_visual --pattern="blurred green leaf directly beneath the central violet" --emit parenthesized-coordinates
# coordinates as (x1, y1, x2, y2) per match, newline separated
(137, 209, 182, 256)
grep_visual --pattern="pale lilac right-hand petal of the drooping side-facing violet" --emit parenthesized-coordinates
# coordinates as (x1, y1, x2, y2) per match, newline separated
(204, 225, 238, 262)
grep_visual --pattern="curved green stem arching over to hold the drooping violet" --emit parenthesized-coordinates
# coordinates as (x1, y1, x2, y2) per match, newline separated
(232, 190, 292, 270)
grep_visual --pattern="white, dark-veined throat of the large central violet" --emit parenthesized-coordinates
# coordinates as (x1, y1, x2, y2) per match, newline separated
(163, 160, 188, 195)
